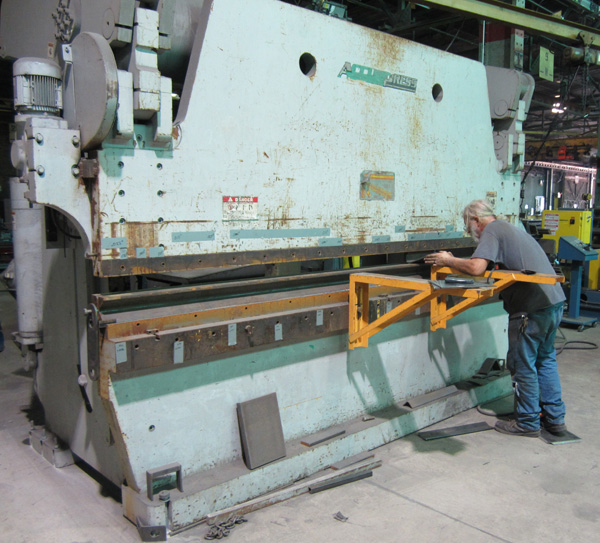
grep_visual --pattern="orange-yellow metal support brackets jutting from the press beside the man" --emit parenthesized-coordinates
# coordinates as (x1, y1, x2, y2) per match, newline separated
(348, 266, 565, 349)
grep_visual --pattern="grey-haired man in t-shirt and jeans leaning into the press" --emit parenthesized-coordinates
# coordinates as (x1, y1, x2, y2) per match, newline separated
(425, 200, 566, 437)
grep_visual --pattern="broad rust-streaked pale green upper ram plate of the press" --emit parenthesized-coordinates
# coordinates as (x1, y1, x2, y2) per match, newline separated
(89, 0, 518, 272)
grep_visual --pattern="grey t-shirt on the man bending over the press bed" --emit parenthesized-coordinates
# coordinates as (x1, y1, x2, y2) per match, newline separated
(471, 219, 565, 315)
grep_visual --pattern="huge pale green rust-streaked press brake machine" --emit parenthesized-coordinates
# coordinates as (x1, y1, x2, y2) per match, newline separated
(0, 0, 533, 539)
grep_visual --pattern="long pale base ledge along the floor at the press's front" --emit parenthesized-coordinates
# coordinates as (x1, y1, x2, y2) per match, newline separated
(122, 374, 512, 534)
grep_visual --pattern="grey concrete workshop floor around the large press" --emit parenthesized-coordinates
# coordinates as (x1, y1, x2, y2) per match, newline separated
(0, 284, 600, 543)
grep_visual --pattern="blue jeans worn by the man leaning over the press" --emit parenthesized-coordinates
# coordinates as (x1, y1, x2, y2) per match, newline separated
(506, 303, 565, 430)
